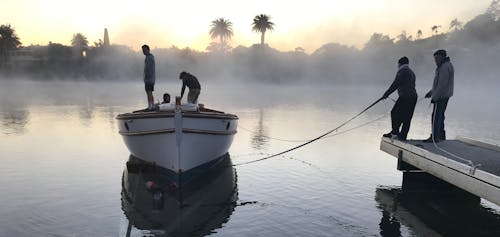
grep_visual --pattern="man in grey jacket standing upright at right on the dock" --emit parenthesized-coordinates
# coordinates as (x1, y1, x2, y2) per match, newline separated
(424, 49, 455, 142)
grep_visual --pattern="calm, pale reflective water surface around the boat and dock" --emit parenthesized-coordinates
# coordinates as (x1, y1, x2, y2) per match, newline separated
(0, 78, 500, 236)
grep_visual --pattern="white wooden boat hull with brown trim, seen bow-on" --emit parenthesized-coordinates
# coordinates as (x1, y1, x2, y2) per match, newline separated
(117, 107, 238, 173)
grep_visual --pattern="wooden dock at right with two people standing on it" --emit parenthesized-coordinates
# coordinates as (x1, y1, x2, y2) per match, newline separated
(380, 138, 500, 206)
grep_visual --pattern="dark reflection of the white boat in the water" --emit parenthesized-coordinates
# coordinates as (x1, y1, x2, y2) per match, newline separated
(121, 155, 238, 236)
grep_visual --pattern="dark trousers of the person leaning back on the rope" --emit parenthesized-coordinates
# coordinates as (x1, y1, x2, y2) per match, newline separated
(391, 96, 417, 140)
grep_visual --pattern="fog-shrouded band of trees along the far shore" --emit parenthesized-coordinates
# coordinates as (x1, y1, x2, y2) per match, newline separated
(0, 2, 500, 87)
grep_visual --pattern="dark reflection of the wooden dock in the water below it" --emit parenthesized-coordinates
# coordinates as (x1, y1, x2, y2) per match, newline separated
(375, 187, 500, 237)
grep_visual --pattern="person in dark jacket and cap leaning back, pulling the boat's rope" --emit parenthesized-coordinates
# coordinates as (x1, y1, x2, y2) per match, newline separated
(382, 57, 417, 141)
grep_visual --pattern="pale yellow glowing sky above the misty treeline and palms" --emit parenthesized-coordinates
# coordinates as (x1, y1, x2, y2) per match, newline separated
(0, 0, 491, 53)
